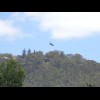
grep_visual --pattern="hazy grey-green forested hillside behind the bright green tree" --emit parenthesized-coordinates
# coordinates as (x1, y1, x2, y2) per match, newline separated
(0, 49, 100, 87)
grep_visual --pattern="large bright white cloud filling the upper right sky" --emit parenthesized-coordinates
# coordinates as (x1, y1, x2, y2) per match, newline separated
(10, 12, 100, 39)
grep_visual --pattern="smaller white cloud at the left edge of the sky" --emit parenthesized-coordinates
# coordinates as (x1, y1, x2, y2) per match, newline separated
(0, 20, 30, 41)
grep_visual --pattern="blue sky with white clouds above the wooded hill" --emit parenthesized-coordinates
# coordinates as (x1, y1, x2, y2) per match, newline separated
(0, 12, 100, 62)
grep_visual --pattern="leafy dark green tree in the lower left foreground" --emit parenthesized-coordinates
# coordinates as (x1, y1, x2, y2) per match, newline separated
(0, 59, 25, 87)
